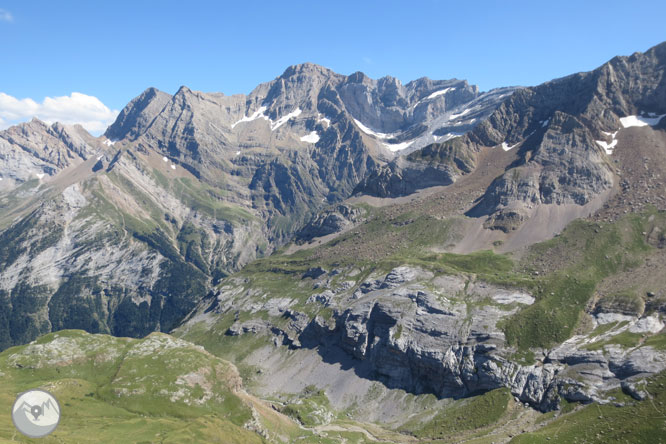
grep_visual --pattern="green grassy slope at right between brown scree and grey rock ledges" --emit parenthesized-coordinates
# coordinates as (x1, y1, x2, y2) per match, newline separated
(501, 212, 665, 349)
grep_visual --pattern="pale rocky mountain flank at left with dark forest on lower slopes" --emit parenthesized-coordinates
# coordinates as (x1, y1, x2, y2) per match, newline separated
(0, 122, 265, 349)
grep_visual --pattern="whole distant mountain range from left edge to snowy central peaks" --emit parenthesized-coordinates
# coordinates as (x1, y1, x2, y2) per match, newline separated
(0, 59, 513, 347)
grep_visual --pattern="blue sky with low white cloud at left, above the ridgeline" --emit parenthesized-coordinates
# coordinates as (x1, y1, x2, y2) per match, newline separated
(0, 0, 666, 132)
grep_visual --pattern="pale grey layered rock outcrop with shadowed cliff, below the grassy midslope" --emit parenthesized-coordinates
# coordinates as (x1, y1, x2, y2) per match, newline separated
(195, 266, 666, 411)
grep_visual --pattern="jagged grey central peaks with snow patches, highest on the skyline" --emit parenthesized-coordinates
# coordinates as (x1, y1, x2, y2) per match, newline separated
(106, 63, 513, 242)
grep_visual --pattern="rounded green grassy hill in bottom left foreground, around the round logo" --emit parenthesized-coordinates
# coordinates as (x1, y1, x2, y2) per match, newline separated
(0, 330, 263, 443)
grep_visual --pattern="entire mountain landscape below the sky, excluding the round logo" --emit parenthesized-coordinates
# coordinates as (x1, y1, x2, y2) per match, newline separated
(0, 43, 666, 443)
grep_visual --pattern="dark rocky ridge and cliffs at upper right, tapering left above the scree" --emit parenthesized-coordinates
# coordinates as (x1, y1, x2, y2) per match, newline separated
(364, 44, 666, 220)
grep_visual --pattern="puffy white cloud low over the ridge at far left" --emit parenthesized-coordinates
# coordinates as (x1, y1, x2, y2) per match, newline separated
(0, 92, 118, 134)
